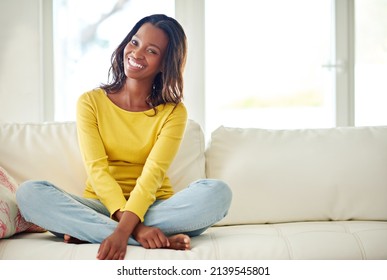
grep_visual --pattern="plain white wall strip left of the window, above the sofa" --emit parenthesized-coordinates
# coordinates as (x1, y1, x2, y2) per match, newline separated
(0, 0, 43, 122)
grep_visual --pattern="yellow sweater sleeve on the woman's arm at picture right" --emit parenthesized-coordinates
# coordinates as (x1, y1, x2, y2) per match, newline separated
(122, 103, 187, 221)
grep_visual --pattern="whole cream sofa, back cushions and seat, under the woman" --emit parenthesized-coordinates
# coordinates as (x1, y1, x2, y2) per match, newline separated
(0, 120, 387, 260)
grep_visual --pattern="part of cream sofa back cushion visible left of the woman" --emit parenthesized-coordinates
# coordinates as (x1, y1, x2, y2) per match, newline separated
(0, 122, 86, 195)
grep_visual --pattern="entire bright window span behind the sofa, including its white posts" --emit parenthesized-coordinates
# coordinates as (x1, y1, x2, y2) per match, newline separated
(53, 0, 387, 132)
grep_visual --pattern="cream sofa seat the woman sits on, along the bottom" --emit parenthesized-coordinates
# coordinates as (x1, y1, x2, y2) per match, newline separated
(0, 221, 387, 260)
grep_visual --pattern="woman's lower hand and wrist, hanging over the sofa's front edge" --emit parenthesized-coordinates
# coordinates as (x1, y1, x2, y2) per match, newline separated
(97, 211, 140, 260)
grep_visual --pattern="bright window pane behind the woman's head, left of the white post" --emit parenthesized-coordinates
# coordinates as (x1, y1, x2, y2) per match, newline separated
(53, 0, 174, 121)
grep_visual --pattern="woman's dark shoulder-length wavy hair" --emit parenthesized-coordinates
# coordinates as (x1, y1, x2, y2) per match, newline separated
(101, 14, 187, 108)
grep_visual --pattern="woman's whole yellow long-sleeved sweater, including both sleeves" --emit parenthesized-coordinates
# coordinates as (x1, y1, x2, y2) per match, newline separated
(77, 89, 187, 221)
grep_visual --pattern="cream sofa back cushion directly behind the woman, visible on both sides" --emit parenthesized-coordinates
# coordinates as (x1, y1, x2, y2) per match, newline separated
(0, 120, 205, 195)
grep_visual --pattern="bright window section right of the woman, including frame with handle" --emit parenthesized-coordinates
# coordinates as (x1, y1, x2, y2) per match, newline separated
(205, 0, 387, 136)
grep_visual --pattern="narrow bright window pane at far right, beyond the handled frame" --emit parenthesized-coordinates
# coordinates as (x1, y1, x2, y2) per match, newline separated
(355, 0, 387, 126)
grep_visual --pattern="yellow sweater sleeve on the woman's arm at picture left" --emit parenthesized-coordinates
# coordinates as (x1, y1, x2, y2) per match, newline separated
(77, 94, 126, 215)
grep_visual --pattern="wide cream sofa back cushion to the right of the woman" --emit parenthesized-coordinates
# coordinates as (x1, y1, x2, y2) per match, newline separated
(206, 127, 387, 225)
